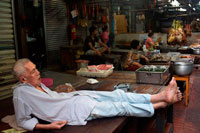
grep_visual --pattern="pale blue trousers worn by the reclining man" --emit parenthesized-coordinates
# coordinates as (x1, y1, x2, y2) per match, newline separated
(87, 89, 154, 120)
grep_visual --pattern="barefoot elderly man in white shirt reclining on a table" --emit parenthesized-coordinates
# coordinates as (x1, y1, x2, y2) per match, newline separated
(13, 59, 182, 130)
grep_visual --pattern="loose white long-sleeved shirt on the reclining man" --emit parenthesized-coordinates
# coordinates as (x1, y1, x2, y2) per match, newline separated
(13, 84, 99, 130)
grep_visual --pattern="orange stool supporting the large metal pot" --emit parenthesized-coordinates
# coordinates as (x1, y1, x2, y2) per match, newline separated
(173, 75, 190, 106)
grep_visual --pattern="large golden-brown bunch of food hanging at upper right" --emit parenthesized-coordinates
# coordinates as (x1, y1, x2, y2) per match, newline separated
(168, 20, 186, 44)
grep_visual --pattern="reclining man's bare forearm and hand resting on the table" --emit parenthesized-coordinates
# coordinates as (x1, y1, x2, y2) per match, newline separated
(35, 121, 67, 130)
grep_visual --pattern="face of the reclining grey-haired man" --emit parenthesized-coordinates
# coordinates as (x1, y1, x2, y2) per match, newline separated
(24, 62, 41, 87)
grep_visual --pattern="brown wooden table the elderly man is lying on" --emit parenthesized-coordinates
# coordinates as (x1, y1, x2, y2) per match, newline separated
(39, 72, 172, 133)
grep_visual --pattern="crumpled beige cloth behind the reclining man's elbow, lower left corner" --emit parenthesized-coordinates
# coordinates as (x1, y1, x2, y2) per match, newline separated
(1, 115, 26, 131)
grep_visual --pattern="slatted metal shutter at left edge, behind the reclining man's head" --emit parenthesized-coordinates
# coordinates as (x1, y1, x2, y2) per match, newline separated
(0, 0, 16, 100)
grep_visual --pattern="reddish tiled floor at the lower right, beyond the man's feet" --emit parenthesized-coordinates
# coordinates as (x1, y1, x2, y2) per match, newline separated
(174, 69, 200, 133)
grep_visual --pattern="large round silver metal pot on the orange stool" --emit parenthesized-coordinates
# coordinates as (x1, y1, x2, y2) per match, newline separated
(174, 61, 193, 76)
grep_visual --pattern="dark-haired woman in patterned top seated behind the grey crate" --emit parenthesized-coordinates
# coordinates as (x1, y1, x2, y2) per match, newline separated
(124, 40, 149, 71)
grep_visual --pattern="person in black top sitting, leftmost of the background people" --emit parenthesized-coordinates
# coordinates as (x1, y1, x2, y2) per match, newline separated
(84, 26, 108, 56)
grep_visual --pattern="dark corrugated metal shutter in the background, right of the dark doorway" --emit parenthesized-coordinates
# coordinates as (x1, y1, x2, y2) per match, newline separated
(43, 0, 69, 64)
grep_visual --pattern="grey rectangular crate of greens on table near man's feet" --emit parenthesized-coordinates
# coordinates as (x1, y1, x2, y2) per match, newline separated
(136, 65, 170, 85)
